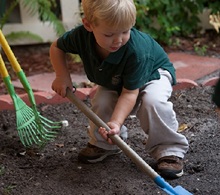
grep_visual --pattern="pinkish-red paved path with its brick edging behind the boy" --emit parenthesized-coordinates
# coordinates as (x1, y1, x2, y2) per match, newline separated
(0, 53, 220, 110)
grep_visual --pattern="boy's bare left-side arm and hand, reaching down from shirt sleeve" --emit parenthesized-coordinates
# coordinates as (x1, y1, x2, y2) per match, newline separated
(50, 41, 72, 97)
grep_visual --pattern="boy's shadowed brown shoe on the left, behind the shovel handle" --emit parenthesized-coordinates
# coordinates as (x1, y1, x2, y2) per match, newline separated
(78, 143, 121, 163)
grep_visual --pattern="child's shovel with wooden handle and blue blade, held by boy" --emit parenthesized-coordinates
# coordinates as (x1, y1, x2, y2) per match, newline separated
(67, 89, 192, 195)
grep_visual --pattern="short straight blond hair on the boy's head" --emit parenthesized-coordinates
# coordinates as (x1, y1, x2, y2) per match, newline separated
(82, 0, 136, 28)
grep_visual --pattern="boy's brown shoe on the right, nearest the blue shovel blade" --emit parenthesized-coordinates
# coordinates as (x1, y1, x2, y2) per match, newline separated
(157, 156, 183, 179)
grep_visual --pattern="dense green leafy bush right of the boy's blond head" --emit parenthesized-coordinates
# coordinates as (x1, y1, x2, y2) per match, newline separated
(135, 0, 220, 44)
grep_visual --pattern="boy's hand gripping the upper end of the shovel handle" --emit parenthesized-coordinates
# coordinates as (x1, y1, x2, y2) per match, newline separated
(52, 77, 73, 97)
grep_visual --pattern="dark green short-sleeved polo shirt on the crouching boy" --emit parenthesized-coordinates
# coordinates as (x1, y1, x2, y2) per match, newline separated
(57, 26, 176, 92)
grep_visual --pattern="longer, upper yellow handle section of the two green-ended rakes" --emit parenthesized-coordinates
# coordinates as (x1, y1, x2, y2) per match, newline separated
(0, 30, 21, 73)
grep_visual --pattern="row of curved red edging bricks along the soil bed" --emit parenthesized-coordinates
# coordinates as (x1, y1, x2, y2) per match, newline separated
(0, 77, 219, 110)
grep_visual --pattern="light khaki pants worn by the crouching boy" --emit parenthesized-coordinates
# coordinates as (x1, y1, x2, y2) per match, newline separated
(88, 69, 188, 160)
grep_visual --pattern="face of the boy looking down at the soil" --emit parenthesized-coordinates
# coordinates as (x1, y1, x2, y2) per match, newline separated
(84, 18, 131, 52)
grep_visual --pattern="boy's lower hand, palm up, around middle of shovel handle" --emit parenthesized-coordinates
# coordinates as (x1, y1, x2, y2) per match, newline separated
(99, 122, 121, 144)
